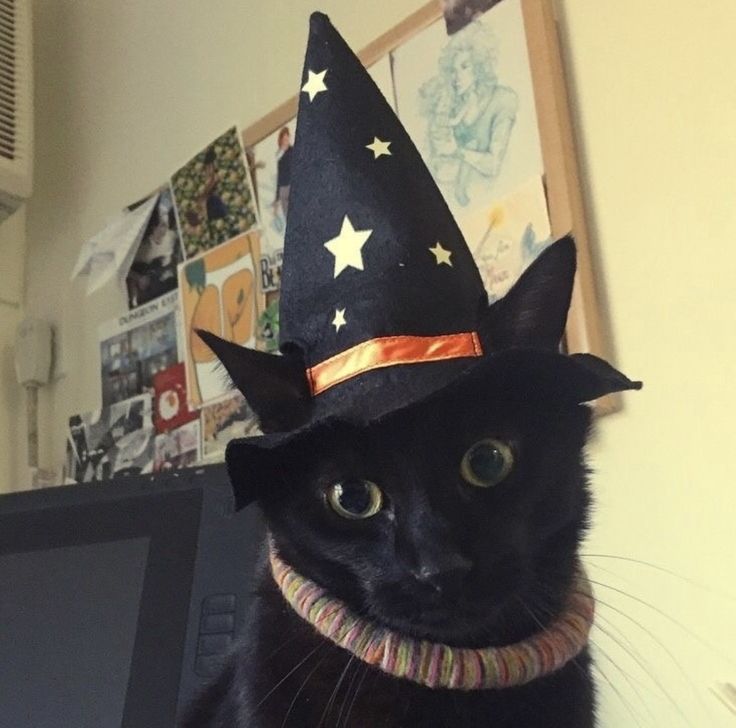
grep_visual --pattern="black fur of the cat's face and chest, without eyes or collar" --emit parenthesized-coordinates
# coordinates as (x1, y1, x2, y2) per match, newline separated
(184, 245, 595, 728)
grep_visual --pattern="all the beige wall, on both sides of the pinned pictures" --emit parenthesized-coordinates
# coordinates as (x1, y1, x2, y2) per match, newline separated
(0, 0, 736, 728)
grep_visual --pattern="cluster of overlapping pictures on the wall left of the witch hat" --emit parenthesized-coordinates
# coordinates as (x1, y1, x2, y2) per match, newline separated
(66, 126, 264, 482)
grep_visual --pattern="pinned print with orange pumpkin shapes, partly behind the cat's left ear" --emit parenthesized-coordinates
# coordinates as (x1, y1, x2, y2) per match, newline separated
(179, 231, 263, 407)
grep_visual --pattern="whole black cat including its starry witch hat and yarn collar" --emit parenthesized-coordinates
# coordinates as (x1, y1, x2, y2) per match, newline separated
(184, 13, 640, 728)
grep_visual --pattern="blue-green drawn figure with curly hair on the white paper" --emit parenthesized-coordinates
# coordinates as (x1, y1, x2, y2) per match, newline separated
(419, 22, 519, 206)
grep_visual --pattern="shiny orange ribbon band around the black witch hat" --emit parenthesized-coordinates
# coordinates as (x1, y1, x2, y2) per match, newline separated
(307, 331, 483, 395)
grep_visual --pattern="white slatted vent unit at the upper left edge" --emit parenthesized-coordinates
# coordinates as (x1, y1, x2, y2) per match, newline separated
(0, 0, 33, 221)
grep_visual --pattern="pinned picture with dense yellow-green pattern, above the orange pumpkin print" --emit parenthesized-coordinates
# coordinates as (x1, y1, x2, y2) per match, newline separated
(171, 127, 257, 258)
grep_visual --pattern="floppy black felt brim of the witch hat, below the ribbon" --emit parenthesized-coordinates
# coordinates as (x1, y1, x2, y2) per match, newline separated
(226, 348, 642, 508)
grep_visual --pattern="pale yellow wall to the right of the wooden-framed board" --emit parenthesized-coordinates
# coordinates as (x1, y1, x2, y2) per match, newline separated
(561, 0, 736, 727)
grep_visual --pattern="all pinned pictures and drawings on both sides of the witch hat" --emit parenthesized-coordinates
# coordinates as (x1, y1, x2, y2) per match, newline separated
(67, 0, 551, 481)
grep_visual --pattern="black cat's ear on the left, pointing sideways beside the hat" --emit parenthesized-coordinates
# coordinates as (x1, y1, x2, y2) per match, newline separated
(196, 329, 311, 432)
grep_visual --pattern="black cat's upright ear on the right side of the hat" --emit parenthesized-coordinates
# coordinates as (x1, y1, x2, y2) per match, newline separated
(482, 236, 575, 349)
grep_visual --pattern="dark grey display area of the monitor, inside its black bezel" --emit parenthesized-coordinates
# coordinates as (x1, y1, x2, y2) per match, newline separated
(0, 538, 148, 728)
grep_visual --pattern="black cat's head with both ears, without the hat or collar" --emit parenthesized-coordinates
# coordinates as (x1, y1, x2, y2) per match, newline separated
(200, 241, 622, 645)
